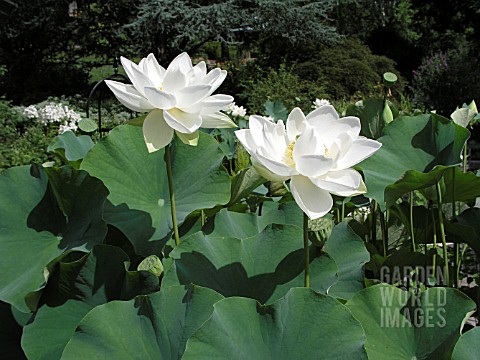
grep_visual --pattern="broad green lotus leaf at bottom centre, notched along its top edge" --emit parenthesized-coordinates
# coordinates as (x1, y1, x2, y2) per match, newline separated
(183, 288, 367, 360)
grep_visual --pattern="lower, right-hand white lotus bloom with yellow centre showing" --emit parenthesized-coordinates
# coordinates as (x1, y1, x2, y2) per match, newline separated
(235, 105, 381, 219)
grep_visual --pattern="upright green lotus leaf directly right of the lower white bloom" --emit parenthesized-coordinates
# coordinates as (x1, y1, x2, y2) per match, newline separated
(358, 114, 470, 207)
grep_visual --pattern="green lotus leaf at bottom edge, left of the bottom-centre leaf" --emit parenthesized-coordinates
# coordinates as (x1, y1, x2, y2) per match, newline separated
(62, 285, 222, 360)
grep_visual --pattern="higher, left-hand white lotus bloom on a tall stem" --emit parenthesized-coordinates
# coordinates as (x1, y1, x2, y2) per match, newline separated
(105, 53, 236, 152)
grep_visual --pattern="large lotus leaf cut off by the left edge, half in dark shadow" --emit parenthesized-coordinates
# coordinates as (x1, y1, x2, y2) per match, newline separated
(0, 165, 107, 312)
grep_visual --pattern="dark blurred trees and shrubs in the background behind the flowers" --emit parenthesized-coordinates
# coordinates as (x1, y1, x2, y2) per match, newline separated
(0, 0, 480, 115)
